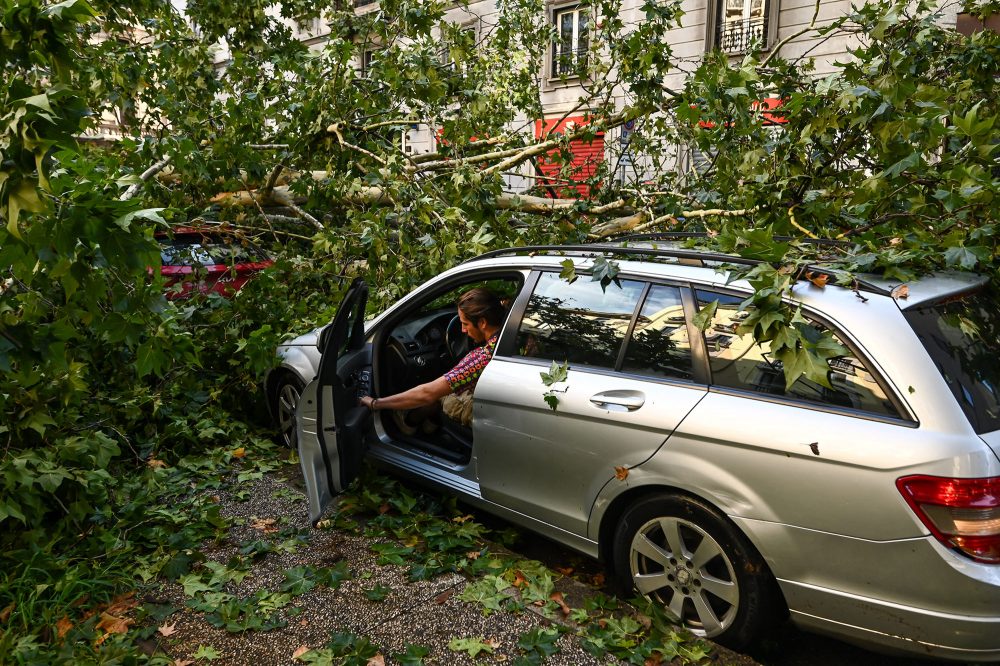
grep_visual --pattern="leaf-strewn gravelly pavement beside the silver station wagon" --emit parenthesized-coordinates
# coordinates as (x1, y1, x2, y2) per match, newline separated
(146, 466, 755, 666)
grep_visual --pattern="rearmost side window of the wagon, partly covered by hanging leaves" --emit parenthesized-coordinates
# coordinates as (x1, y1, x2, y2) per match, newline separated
(697, 290, 899, 417)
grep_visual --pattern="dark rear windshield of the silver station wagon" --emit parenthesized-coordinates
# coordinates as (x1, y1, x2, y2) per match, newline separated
(904, 290, 1000, 433)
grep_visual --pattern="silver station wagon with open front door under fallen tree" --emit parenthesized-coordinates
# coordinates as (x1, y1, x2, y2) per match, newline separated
(268, 241, 1000, 661)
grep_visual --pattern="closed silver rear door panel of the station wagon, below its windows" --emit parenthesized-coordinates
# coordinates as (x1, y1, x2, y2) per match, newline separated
(475, 358, 705, 535)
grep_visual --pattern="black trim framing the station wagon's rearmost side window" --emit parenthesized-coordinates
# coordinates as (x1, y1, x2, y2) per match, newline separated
(690, 283, 919, 427)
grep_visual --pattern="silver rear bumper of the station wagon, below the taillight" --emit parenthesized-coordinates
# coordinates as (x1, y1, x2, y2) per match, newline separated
(734, 518, 1000, 661)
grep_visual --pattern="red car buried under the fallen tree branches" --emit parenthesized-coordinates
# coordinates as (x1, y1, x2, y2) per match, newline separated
(157, 227, 274, 299)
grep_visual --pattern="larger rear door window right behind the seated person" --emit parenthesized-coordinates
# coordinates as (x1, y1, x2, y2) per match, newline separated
(517, 273, 645, 368)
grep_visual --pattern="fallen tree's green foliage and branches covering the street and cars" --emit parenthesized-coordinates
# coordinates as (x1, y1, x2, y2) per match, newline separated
(0, 0, 1000, 657)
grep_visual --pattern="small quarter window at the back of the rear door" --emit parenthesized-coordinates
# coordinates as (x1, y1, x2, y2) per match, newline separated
(622, 285, 694, 380)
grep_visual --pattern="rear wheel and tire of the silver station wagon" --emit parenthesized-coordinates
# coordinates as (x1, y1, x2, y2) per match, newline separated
(613, 495, 781, 649)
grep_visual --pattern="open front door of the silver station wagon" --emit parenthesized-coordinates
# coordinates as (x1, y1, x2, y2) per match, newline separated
(296, 278, 371, 525)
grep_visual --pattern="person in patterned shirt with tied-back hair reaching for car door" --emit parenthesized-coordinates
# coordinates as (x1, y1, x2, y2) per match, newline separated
(361, 287, 506, 426)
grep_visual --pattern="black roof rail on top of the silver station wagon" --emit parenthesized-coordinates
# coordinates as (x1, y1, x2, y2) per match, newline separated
(467, 239, 890, 296)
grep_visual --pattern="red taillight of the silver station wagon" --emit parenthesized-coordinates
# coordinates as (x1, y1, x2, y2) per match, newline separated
(896, 475, 1000, 564)
